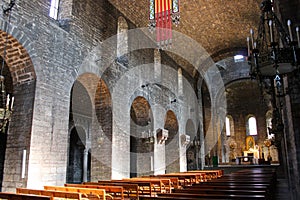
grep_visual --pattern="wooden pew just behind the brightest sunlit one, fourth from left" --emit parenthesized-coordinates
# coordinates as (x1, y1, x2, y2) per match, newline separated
(65, 184, 124, 199)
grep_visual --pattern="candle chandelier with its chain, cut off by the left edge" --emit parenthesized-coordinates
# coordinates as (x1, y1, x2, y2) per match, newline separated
(0, 0, 15, 132)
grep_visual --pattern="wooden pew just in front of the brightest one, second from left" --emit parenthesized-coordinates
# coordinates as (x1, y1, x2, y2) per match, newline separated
(16, 188, 82, 200)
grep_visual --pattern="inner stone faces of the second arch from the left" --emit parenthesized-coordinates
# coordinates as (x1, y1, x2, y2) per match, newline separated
(69, 73, 112, 180)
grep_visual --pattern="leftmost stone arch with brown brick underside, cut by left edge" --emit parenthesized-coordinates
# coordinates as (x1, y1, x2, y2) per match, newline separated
(0, 25, 36, 190)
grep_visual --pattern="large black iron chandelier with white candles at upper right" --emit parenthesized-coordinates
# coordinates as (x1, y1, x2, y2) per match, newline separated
(247, 0, 300, 142)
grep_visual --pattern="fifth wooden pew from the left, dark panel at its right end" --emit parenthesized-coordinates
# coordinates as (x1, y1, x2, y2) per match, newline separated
(83, 181, 139, 199)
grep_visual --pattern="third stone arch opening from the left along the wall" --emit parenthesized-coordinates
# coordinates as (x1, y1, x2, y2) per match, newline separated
(130, 96, 154, 177)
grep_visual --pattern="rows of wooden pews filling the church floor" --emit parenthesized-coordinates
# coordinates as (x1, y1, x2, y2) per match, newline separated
(0, 167, 289, 200)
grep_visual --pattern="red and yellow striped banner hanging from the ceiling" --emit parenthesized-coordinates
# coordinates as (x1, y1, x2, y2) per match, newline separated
(149, 0, 180, 48)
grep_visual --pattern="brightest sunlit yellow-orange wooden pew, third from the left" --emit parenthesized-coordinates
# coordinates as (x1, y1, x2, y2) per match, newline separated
(44, 186, 107, 200)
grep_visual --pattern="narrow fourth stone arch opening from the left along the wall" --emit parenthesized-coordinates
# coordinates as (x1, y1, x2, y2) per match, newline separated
(164, 110, 180, 173)
